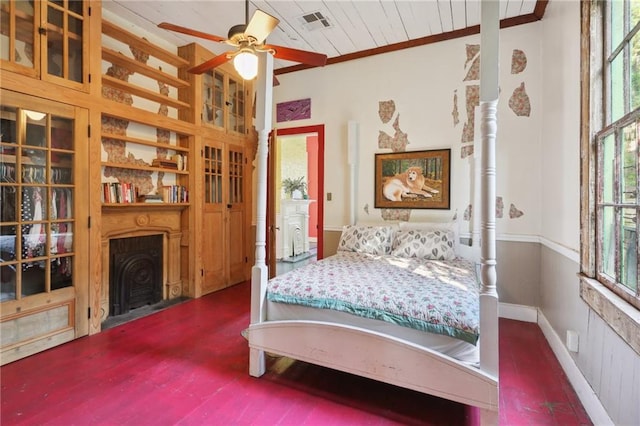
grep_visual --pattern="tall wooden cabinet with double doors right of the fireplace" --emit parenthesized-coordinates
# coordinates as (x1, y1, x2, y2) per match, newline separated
(178, 43, 256, 294)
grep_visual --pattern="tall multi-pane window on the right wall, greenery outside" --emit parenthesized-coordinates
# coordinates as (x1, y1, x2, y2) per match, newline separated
(583, 0, 640, 308)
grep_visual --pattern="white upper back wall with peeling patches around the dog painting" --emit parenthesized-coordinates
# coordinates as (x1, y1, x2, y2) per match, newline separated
(274, 23, 542, 240)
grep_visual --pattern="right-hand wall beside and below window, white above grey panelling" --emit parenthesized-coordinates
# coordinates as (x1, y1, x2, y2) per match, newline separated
(539, 1, 640, 425)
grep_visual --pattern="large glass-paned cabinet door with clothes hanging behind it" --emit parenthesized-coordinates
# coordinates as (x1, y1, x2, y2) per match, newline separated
(0, 106, 75, 302)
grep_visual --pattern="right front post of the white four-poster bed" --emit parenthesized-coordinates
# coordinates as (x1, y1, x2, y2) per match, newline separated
(480, 0, 500, 425)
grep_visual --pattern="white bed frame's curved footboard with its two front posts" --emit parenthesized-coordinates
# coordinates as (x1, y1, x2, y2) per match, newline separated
(247, 0, 499, 425)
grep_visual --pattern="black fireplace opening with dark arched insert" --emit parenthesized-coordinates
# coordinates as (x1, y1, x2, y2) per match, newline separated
(109, 234, 163, 316)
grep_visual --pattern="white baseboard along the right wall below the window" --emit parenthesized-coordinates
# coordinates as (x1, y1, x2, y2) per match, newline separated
(538, 311, 614, 426)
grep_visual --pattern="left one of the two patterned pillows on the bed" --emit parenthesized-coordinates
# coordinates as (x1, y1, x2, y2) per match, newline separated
(338, 225, 393, 255)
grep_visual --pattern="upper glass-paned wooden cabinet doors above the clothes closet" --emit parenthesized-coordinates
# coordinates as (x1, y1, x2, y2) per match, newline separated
(0, 0, 90, 91)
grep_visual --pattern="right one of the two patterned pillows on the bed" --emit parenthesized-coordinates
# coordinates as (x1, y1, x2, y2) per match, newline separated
(391, 229, 456, 260)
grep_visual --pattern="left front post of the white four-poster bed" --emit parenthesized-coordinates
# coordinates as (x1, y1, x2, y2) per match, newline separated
(249, 53, 273, 377)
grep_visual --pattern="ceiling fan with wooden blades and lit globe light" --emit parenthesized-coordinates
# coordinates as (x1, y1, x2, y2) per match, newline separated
(158, 0, 327, 80)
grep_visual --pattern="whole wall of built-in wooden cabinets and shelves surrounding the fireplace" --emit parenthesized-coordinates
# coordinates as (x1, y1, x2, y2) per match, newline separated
(0, 5, 256, 363)
